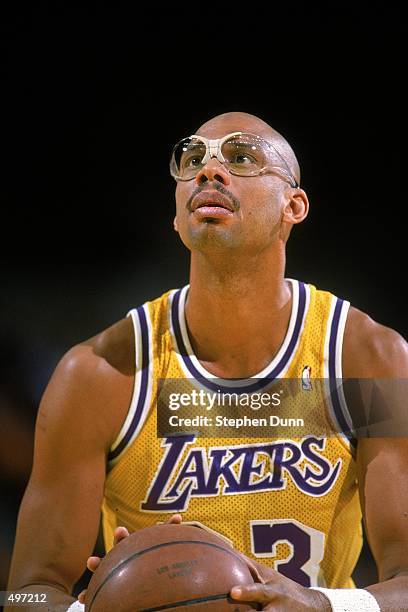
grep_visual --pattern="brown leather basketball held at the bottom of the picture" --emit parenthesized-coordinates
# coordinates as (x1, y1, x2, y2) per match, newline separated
(85, 524, 259, 612)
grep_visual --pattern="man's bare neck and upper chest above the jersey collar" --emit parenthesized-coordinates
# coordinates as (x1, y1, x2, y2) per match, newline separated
(186, 253, 292, 378)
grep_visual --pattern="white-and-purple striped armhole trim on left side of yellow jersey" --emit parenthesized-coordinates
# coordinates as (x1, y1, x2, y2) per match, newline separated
(108, 304, 153, 469)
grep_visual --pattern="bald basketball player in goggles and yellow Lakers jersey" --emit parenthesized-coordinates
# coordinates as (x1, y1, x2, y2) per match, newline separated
(9, 113, 408, 612)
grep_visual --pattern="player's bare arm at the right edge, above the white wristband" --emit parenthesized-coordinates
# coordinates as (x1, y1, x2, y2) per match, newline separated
(344, 309, 408, 612)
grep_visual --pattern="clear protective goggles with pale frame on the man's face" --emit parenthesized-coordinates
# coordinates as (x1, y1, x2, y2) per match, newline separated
(170, 132, 299, 187)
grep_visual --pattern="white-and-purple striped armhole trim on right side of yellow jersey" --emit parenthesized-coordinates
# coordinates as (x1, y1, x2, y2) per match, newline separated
(324, 295, 356, 452)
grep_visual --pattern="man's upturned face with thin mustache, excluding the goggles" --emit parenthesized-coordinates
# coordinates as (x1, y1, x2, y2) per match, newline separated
(175, 117, 290, 256)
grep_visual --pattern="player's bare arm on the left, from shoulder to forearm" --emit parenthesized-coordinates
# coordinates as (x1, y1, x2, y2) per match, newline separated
(8, 321, 133, 610)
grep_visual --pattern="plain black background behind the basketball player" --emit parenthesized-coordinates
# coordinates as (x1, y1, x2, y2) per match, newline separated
(0, 2, 408, 590)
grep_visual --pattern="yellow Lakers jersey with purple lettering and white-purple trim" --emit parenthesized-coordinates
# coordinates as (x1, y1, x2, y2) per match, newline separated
(102, 279, 362, 588)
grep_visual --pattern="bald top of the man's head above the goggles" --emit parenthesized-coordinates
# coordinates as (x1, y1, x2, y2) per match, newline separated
(196, 112, 300, 184)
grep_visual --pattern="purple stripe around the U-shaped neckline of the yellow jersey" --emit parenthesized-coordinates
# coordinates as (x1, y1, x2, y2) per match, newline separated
(171, 282, 306, 393)
